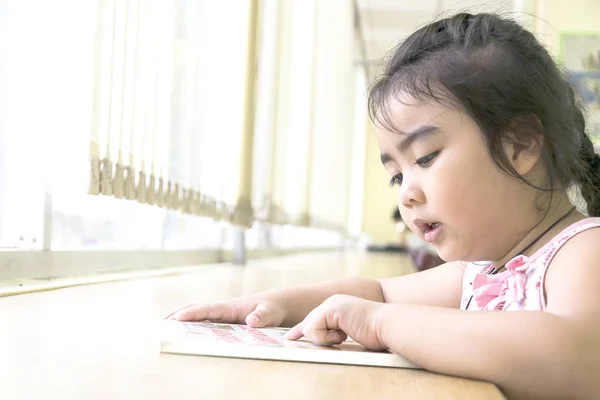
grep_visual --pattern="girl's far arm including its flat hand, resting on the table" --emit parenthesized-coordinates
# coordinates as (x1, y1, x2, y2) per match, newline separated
(166, 258, 463, 327)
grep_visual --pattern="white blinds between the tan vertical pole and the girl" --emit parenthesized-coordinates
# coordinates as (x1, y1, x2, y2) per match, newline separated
(254, 0, 358, 232)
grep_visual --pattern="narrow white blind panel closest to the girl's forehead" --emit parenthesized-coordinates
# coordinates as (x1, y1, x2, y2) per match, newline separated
(308, 0, 358, 232)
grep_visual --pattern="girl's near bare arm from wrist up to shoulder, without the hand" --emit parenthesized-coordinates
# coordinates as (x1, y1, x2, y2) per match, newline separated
(374, 229, 600, 399)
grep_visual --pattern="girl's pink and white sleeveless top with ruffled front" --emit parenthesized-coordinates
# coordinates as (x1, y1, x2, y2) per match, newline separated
(460, 218, 600, 311)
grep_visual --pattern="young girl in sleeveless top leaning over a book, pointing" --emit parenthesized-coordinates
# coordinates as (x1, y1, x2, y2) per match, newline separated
(169, 14, 600, 399)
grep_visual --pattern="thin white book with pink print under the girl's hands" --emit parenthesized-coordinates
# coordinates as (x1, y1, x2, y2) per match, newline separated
(161, 320, 419, 368)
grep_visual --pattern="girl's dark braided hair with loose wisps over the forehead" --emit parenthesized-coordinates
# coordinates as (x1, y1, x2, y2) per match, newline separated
(368, 13, 600, 216)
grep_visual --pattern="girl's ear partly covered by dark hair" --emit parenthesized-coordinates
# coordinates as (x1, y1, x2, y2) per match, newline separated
(504, 115, 544, 176)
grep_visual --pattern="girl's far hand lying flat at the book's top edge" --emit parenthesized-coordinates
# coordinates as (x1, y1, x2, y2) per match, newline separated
(165, 296, 286, 328)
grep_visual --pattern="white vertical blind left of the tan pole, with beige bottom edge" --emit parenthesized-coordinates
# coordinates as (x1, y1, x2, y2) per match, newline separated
(89, 0, 251, 220)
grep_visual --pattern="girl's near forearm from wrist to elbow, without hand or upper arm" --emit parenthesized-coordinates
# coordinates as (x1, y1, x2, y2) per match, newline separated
(378, 304, 600, 399)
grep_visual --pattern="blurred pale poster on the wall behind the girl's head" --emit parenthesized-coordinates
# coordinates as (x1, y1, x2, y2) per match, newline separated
(561, 31, 600, 149)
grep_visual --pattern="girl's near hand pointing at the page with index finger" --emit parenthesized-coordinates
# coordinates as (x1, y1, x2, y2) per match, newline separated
(286, 294, 387, 350)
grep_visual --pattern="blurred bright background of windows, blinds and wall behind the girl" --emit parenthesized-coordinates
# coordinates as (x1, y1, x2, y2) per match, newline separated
(0, 0, 600, 280)
